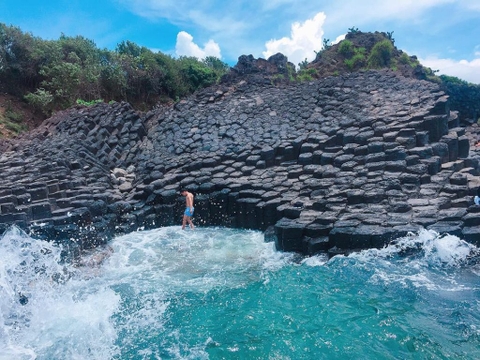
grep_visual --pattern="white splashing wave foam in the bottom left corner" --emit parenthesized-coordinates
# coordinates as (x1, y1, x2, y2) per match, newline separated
(0, 228, 119, 359)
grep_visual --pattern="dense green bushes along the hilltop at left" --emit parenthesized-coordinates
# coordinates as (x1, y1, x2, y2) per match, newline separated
(0, 23, 229, 115)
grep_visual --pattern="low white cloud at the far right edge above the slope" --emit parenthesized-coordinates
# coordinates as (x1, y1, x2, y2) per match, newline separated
(419, 57, 480, 84)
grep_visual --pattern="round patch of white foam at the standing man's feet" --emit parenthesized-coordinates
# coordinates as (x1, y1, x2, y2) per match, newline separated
(106, 226, 293, 292)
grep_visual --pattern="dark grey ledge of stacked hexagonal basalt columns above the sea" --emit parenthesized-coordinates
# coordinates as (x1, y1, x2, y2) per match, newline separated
(0, 66, 480, 254)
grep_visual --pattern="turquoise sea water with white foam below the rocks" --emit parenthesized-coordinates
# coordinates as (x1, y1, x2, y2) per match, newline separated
(0, 226, 480, 360)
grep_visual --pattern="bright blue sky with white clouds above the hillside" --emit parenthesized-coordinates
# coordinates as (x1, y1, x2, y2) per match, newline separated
(0, 0, 480, 84)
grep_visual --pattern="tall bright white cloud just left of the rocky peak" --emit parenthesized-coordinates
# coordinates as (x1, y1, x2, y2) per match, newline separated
(263, 12, 326, 65)
